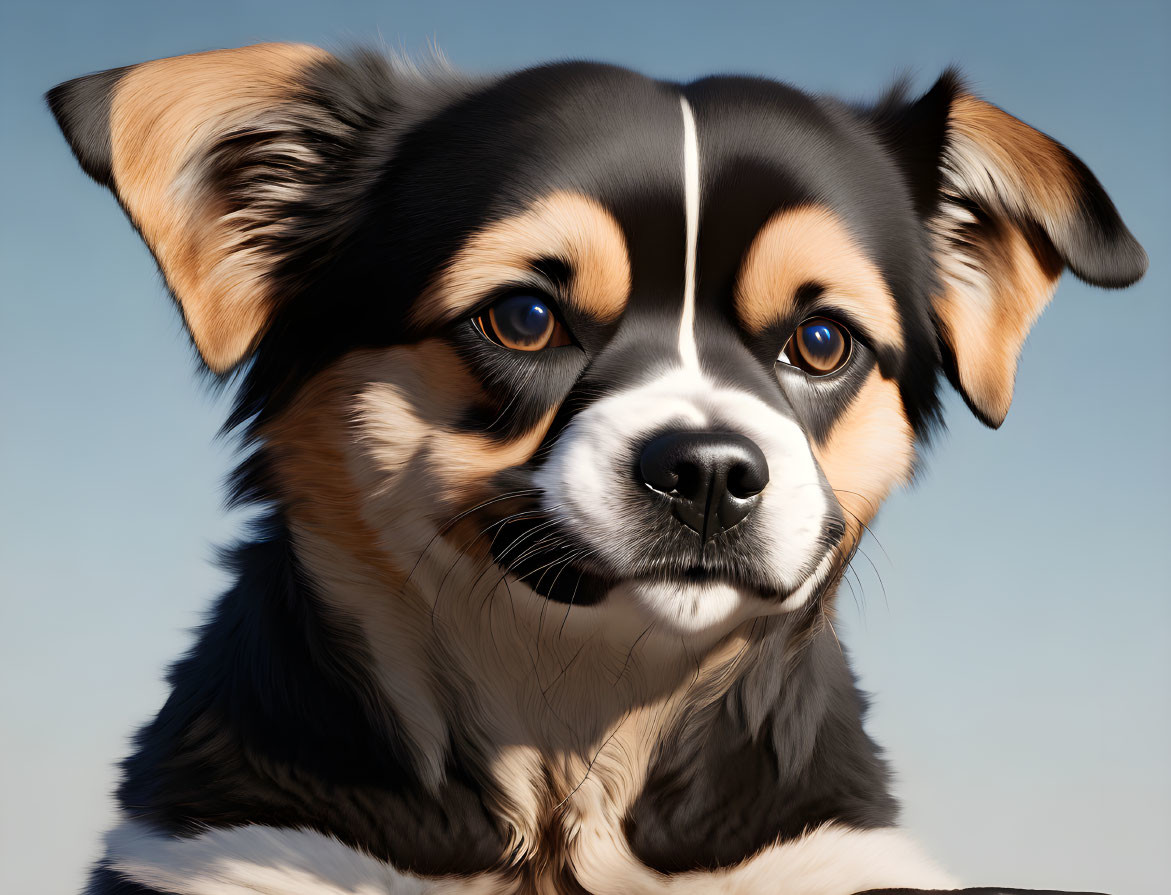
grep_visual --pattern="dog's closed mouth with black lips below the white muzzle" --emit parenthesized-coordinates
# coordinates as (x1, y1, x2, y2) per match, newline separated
(491, 512, 815, 606)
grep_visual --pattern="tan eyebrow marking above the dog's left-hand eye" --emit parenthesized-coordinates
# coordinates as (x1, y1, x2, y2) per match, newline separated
(412, 191, 630, 326)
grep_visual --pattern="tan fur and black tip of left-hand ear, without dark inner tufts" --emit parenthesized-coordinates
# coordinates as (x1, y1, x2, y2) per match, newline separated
(49, 43, 329, 373)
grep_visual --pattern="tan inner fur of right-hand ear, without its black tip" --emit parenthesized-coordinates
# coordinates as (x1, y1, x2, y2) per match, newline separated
(931, 94, 1084, 426)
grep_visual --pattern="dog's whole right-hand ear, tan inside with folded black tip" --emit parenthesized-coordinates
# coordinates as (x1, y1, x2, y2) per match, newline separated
(874, 71, 1146, 428)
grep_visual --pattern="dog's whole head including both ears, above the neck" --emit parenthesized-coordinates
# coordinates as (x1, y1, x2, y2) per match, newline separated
(50, 46, 1145, 631)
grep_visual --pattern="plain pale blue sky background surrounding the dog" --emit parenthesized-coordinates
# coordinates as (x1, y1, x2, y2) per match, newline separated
(0, 0, 1171, 895)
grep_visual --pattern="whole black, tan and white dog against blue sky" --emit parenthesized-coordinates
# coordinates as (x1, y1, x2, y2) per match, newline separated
(47, 45, 1146, 895)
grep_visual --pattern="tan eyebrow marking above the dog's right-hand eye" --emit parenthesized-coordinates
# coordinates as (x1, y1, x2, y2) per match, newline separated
(735, 205, 903, 349)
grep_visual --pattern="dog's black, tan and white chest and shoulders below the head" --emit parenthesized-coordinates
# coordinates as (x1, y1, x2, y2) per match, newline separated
(97, 520, 938, 895)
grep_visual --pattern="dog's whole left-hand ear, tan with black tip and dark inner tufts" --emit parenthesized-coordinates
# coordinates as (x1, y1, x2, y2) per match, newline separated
(47, 43, 402, 373)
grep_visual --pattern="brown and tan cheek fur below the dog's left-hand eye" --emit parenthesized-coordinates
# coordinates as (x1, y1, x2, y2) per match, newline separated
(256, 340, 554, 576)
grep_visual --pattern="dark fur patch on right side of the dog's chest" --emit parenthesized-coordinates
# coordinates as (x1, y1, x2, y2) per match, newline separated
(625, 629, 897, 873)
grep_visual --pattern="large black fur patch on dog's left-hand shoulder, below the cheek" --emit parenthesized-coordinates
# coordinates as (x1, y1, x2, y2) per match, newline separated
(118, 517, 505, 874)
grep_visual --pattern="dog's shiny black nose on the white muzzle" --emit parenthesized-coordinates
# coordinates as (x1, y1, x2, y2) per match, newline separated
(638, 432, 768, 541)
